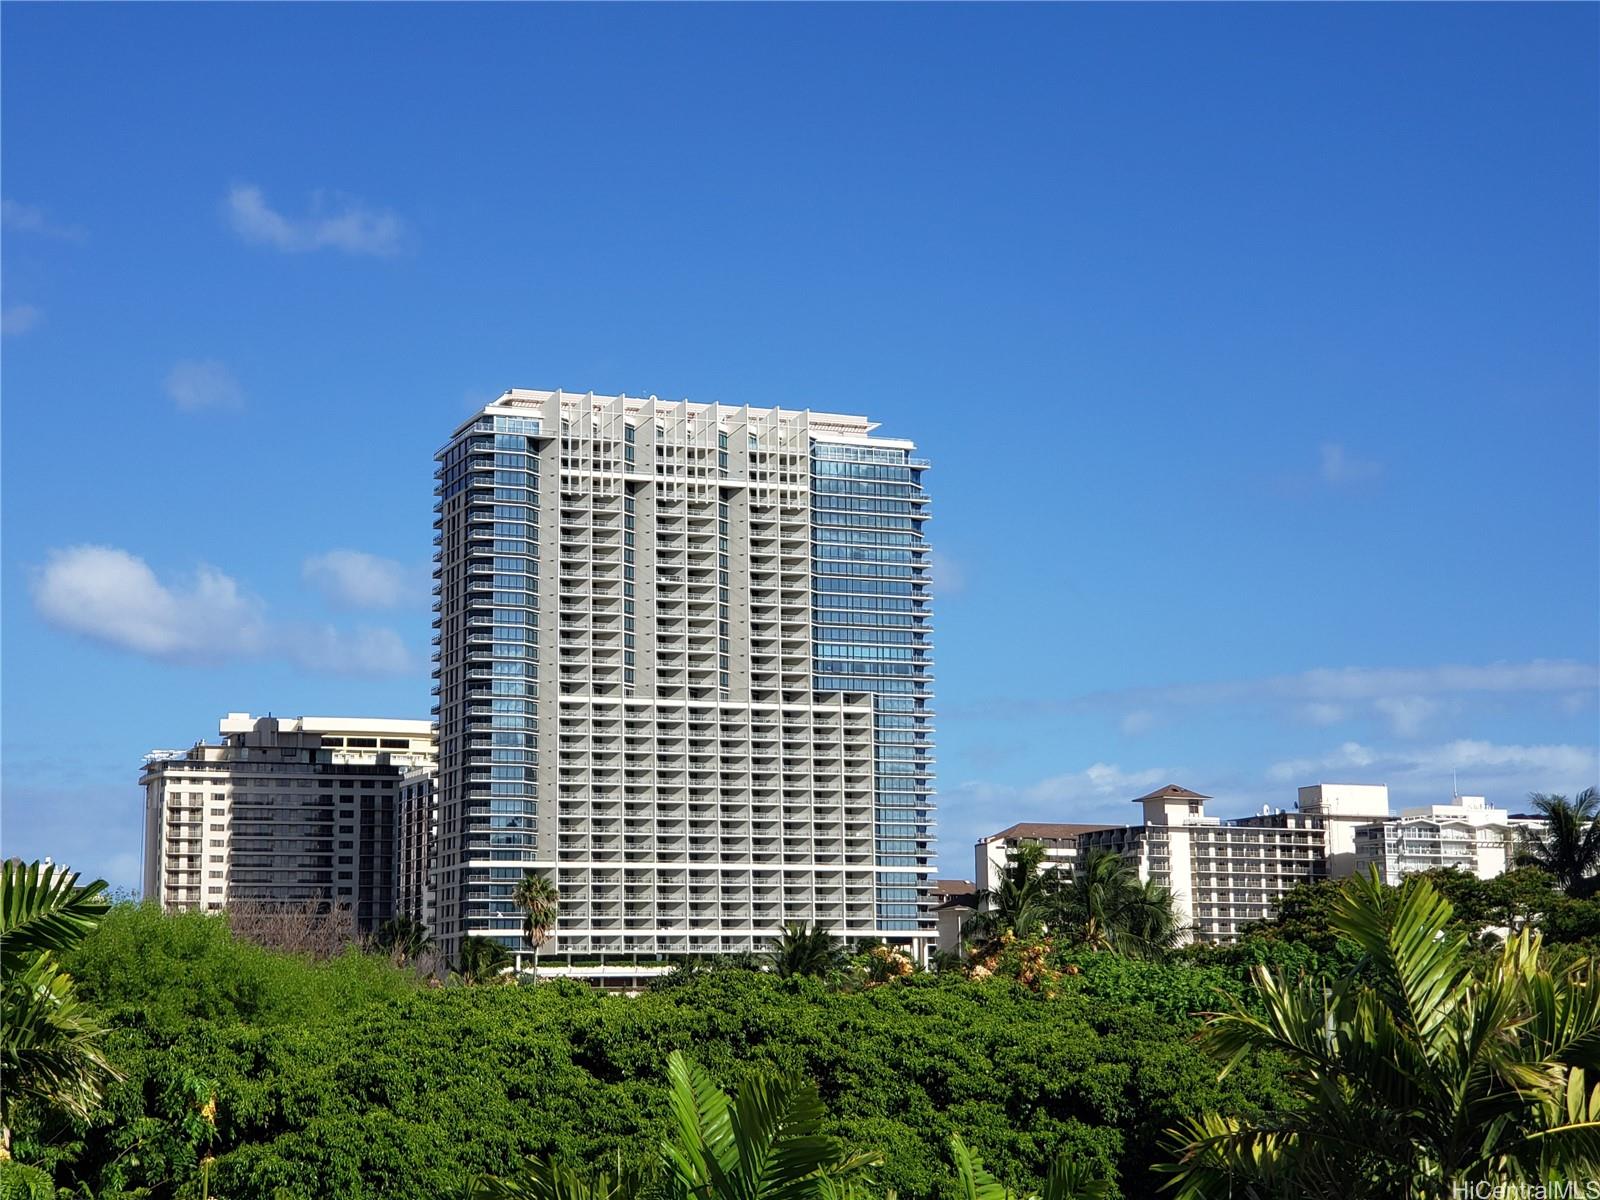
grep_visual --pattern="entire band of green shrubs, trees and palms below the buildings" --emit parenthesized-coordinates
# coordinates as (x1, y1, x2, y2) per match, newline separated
(0, 872, 1600, 1200)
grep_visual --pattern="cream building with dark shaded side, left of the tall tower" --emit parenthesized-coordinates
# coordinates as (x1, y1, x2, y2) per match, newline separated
(139, 712, 434, 931)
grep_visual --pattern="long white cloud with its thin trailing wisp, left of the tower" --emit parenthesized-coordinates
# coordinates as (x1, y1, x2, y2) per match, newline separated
(34, 546, 416, 675)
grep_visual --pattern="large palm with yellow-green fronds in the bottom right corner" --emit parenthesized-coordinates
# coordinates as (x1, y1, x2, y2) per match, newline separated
(1168, 872, 1600, 1200)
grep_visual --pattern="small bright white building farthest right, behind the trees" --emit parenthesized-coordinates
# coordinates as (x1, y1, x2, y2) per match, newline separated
(1355, 795, 1517, 885)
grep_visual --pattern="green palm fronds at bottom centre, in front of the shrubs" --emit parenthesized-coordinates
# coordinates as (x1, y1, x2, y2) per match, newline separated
(470, 1051, 883, 1200)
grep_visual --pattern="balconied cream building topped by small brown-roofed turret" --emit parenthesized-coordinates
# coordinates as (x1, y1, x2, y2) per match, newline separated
(1078, 784, 1328, 942)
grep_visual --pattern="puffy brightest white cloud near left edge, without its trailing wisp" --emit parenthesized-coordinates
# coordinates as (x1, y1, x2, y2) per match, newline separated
(34, 546, 266, 662)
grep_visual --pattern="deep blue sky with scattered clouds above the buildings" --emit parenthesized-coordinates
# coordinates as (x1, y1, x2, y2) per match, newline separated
(0, 5, 1600, 886)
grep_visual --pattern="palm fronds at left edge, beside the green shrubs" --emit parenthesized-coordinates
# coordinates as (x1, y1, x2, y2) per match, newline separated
(0, 859, 120, 1152)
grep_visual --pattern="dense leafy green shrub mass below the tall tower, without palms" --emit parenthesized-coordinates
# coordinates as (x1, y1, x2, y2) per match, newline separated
(30, 907, 1299, 1200)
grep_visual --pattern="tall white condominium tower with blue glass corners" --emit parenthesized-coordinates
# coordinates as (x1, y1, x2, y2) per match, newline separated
(434, 390, 936, 962)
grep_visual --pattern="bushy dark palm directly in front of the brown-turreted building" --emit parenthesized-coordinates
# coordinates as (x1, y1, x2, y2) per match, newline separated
(1048, 850, 1181, 958)
